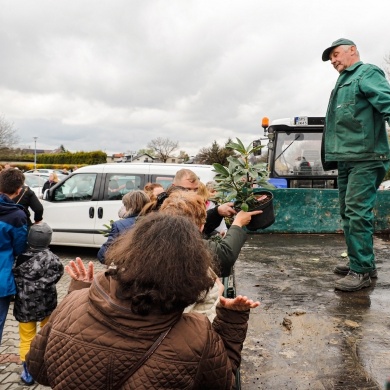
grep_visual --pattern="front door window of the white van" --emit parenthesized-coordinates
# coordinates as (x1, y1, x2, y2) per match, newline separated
(54, 173, 97, 202)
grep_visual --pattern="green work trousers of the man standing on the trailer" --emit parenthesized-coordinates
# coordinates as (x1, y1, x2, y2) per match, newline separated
(338, 161, 390, 273)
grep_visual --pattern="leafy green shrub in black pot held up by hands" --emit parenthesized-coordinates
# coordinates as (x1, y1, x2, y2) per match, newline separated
(213, 138, 275, 230)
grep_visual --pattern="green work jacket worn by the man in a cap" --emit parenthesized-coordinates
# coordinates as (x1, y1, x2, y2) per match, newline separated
(324, 61, 390, 161)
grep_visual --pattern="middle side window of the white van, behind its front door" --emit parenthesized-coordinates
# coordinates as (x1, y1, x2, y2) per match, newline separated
(105, 174, 144, 200)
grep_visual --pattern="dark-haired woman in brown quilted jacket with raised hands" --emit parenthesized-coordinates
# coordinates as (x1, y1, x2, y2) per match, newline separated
(27, 213, 259, 390)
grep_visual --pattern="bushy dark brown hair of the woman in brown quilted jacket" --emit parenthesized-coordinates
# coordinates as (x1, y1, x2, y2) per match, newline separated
(106, 212, 214, 315)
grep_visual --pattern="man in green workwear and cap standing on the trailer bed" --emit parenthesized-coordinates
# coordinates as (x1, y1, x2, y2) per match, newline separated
(322, 38, 390, 291)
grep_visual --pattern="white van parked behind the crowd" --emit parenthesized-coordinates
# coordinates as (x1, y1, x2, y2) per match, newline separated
(42, 163, 214, 247)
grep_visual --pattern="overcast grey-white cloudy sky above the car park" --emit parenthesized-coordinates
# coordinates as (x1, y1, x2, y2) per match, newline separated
(0, 0, 390, 155)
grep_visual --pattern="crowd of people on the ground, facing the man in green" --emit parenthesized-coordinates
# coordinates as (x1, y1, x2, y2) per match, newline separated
(0, 164, 261, 389)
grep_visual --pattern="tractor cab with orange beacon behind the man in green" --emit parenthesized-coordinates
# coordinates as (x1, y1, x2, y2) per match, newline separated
(262, 116, 337, 188)
